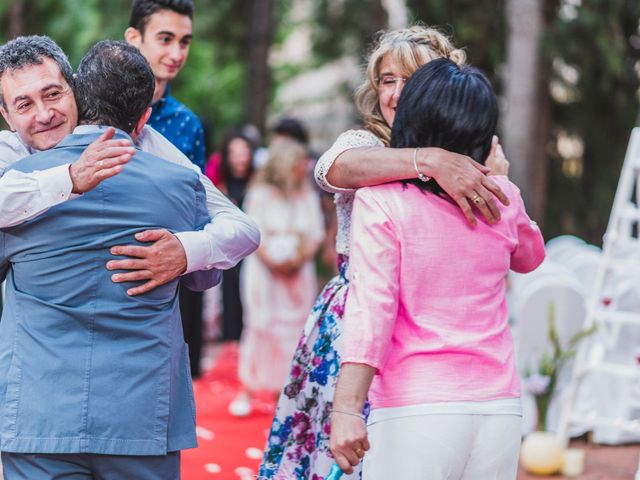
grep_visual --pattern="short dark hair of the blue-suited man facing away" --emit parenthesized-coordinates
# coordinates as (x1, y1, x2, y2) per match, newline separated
(75, 40, 155, 133)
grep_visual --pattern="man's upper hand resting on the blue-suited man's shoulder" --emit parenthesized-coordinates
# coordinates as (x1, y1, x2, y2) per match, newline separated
(69, 128, 135, 193)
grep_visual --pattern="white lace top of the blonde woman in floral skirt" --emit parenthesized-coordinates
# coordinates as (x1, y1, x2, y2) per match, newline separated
(315, 130, 384, 255)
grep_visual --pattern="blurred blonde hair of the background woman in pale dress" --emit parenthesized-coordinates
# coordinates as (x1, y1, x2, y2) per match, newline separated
(255, 138, 311, 197)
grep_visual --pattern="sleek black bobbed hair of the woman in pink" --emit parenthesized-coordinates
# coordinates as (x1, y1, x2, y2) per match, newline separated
(391, 58, 498, 195)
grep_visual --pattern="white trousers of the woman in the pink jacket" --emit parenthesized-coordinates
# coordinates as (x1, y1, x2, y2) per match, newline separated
(362, 415, 522, 480)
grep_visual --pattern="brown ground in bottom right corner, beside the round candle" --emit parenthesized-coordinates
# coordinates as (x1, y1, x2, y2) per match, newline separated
(518, 441, 640, 480)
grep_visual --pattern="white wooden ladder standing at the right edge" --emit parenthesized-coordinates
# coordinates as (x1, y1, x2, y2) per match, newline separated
(558, 127, 640, 480)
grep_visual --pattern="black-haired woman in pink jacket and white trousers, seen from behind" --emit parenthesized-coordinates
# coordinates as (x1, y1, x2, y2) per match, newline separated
(331, 59, 544, 480)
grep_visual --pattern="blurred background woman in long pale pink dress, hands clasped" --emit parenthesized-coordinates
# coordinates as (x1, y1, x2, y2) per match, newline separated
(229, 139, 324, 416)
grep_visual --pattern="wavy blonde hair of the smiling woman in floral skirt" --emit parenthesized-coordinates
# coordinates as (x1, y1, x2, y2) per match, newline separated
(355, 25, 466, 146)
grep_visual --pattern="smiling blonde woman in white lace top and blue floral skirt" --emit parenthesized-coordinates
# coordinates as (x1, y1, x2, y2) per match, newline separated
(259, 26, 508, 480)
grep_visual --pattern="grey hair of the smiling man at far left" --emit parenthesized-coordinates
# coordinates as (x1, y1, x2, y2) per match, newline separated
(0, 35, 73, 108)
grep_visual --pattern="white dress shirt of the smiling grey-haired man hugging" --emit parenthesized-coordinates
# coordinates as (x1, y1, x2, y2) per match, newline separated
(0, 125, 260, 273)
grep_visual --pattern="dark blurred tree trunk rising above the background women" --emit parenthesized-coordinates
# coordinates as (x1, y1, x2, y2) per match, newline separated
(247, 0, 274, 133)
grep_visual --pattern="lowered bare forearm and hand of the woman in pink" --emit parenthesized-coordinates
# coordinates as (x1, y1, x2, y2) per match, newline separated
(329, 363, 375, 474)
